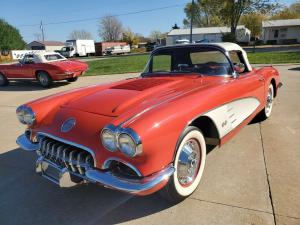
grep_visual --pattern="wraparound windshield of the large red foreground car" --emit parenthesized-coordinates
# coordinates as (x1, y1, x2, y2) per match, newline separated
(143, 46, 232, 76)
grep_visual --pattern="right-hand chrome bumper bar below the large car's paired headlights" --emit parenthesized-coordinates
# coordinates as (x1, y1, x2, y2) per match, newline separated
(86, 165, 175, 194)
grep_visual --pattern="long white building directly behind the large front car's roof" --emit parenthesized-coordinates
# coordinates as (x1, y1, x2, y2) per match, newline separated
(167, 25, 251, 45)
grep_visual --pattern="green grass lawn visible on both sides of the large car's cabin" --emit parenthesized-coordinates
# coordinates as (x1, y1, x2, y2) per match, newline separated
(86, 52, 300, 76)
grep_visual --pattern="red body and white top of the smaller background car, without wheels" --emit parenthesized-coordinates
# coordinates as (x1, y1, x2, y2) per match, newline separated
(0, 52, 88, 85)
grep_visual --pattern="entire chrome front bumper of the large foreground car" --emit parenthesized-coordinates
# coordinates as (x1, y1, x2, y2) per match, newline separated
(17, 134, 175, 195)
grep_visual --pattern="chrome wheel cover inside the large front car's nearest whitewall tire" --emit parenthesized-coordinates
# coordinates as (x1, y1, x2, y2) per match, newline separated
(177, 139, 201, 187)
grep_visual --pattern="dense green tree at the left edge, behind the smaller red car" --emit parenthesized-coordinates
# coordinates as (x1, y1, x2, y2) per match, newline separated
(0, 19, 26, 50)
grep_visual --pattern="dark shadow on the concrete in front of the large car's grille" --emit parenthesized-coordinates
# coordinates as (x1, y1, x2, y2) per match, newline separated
(0, 149, 172, 225)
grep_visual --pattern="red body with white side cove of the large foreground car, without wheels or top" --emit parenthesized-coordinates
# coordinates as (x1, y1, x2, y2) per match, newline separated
(18, 45, 280, 200)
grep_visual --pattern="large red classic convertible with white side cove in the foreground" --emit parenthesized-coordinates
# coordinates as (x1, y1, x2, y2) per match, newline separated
(17, 43, 281, 202)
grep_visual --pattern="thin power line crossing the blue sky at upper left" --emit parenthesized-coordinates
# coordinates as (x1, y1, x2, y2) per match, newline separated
(17, 4, 183, 27)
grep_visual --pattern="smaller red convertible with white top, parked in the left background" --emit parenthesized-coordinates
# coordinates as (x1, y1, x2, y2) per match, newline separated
(0, 51, 88, 87)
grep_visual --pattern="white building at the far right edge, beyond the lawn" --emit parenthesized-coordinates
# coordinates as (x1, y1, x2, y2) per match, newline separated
(262, 19, 300, 44)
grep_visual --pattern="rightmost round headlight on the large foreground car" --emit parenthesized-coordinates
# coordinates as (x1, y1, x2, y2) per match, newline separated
(118, 133, 140, 157)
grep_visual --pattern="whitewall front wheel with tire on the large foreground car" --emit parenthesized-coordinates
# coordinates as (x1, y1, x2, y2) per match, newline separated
(160, 126, 206, 203)
